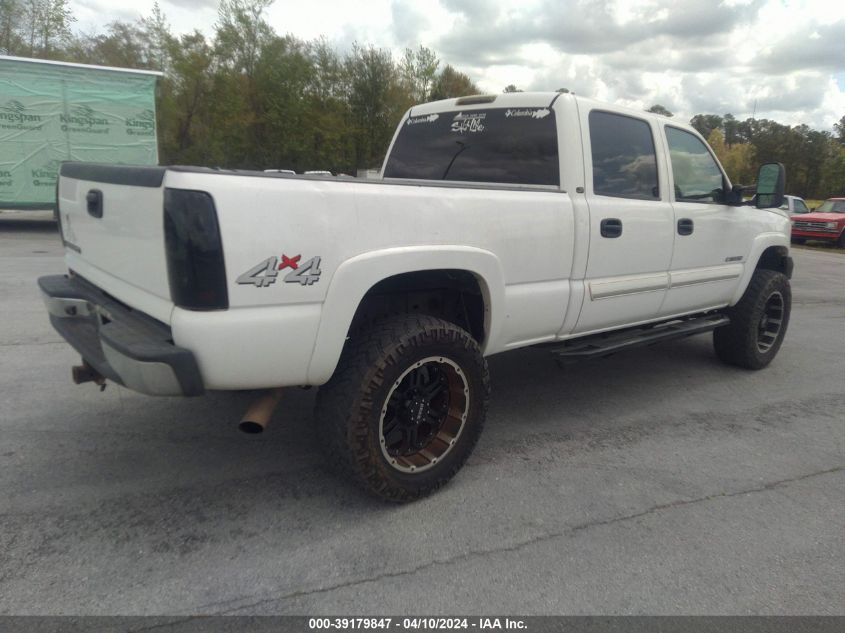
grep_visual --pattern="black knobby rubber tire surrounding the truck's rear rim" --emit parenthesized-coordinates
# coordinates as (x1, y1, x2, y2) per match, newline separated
(315, 315, 490, 502)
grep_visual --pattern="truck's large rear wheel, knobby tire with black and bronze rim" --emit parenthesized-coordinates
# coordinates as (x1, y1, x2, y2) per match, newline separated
(315, 315, 490, 502)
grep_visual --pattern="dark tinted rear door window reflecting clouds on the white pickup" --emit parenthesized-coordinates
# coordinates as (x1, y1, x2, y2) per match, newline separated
(590, 110, 660, 200)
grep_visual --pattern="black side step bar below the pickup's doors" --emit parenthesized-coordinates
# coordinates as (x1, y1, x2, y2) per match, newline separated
(551, 314, 731, 362)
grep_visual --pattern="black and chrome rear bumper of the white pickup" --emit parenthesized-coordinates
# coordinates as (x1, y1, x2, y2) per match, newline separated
(38, 275, 205, 396)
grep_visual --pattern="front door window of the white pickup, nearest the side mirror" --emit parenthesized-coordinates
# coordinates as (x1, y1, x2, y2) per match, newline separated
(665, 125, 725, 202)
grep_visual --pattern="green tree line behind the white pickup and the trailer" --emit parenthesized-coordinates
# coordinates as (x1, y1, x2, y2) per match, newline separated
(0, 0, 845, 198)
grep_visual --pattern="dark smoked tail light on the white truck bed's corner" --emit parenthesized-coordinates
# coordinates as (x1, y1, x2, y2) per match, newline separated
(164, 189, 229, 310)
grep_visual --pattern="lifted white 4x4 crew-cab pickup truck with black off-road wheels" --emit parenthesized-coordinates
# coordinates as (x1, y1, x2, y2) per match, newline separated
(39, 93, 792, 501)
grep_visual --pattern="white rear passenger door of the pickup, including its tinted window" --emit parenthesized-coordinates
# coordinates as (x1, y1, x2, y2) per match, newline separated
(574, 108, 674, 333)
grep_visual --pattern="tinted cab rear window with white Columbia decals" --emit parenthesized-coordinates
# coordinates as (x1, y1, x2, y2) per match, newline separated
(384, 108, 560, 186)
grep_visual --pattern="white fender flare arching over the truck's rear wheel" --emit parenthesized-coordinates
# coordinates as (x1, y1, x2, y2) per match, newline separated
(308, 246, 505, 385)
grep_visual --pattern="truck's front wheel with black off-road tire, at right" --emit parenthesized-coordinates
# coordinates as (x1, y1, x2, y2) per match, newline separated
(713, 269, 792, 369)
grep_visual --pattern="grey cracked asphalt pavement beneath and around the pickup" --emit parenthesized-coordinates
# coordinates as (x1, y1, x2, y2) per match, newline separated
(0, 218, 845, 614)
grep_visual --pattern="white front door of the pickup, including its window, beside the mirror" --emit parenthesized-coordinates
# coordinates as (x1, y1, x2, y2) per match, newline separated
(661, 124, 751, 316)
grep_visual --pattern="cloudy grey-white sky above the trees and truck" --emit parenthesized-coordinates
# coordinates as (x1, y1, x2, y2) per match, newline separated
(70, 0, 845, 130)
